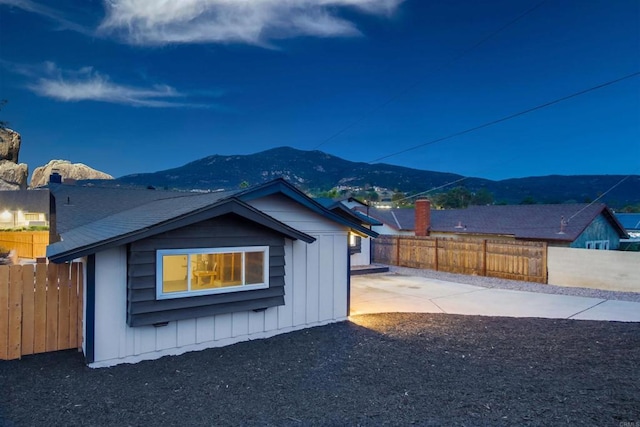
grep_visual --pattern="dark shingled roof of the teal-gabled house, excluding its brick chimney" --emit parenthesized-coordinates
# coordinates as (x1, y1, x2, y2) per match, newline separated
(358, 203, 626, 242)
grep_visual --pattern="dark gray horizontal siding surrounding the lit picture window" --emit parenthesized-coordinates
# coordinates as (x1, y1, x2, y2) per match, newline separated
(127, 215, 284, 326)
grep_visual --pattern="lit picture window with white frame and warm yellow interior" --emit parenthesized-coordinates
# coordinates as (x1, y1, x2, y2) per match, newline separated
(156, 246, 269, 299)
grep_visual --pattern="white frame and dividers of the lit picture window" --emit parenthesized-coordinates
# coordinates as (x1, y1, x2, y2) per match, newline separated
(156, 246, 269, 300)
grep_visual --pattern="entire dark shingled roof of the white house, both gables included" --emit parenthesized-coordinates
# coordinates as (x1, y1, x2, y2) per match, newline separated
(47, 179, 377, 262)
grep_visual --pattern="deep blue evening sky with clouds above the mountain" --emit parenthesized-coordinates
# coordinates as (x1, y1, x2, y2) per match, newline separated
(0, 0, 640, 179)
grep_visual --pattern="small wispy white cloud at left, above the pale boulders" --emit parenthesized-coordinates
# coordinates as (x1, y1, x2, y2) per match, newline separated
(29, 62, 207, 108)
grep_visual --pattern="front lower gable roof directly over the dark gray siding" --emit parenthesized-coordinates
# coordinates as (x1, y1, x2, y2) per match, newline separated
(47, 193, 315, 262)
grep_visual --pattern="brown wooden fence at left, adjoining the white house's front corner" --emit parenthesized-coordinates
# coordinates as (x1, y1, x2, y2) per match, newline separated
(0, 263, 82, 360)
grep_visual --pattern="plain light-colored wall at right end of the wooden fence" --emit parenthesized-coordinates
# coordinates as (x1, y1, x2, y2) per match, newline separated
(547, 246, 640, 292)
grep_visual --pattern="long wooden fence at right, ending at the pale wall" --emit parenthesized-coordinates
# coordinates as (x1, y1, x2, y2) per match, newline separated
(372, 236, 547, 283)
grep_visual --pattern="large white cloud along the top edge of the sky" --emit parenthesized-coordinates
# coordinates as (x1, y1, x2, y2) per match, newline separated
(100, 0, 404, 45)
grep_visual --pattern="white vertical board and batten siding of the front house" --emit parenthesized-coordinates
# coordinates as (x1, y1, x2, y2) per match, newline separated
(90, 200, 349, 367)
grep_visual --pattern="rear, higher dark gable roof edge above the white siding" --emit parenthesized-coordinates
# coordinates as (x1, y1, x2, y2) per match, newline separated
(235, 178, 378, 237)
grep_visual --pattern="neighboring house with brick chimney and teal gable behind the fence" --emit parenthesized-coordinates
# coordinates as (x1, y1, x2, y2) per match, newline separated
(358, 200, 627, 249)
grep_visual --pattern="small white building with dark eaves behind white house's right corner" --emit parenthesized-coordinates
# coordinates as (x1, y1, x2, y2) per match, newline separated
(314, 197, 382, 267)
